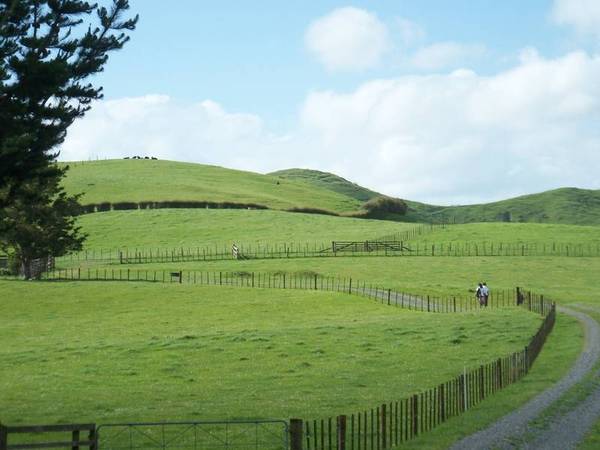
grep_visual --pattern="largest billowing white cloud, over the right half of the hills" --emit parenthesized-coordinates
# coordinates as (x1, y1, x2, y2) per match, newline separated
(302, 51, 600, 203)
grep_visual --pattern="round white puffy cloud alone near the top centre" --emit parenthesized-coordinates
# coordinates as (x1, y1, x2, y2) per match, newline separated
(305, 7, 391, 70)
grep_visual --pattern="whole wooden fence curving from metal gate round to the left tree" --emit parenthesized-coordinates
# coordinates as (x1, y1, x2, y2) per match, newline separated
(25, 268, 556, 450)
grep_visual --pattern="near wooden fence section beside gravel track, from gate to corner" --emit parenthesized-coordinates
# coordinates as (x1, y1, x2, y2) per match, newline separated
(298, 295, 556, 450)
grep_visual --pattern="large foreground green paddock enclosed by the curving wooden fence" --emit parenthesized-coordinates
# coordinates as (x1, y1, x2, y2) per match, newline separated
(0, 281, 541, 424)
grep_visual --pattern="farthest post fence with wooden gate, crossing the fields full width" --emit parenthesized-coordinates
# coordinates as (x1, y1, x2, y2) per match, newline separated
(56, 238, 600, 264)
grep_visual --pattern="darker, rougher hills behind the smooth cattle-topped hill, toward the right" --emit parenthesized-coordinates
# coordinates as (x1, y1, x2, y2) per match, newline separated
(271, 169, 600, 225)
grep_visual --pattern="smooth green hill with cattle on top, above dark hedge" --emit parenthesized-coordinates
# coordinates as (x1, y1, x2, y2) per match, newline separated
(64, 160, 360, 212)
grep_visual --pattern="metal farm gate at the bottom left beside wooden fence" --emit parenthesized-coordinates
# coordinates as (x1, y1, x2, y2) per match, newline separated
(97, 420, 288, 450)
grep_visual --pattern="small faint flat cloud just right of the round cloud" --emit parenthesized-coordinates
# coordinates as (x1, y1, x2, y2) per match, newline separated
(410, 42, 486, 70)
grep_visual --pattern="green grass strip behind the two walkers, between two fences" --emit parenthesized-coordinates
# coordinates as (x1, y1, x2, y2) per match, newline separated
(77, 257, 600, 307)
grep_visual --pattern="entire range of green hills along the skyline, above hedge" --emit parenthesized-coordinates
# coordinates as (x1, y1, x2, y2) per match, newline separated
(64, 160, 600, 225)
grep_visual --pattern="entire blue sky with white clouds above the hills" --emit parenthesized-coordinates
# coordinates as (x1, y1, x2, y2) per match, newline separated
(61, 0, 600, 204)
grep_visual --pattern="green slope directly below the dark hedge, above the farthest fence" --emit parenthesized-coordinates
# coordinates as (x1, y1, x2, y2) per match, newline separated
(78, 209, 415, 250)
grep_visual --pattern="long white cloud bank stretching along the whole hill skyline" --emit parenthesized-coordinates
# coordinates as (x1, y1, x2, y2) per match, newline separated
(62, 49, 600, 203)
